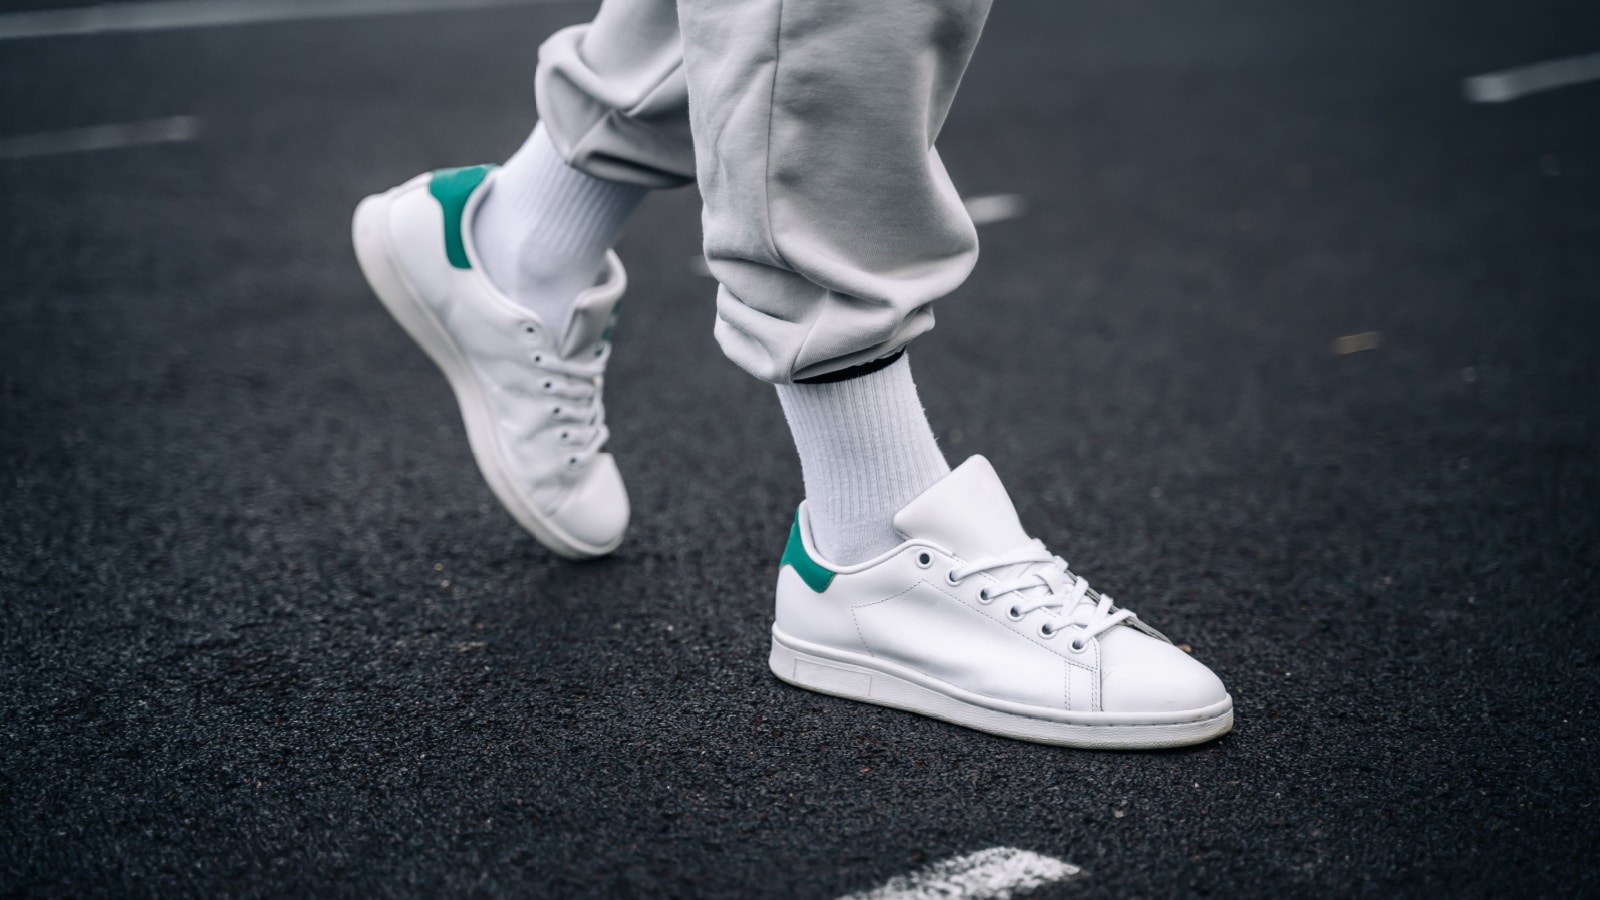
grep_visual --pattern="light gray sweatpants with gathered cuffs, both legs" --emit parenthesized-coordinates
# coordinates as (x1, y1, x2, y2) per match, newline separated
(538, 0, 990, 383)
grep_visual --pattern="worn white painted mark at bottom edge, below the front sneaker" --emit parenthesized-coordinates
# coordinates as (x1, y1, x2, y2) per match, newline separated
(838, 847, 1083, 900)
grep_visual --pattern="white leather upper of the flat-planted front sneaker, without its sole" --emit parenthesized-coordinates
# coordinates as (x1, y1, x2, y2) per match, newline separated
(778, 456, 1227, 714)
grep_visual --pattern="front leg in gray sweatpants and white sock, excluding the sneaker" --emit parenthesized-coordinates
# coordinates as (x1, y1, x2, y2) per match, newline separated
(678, 0, 989, 562)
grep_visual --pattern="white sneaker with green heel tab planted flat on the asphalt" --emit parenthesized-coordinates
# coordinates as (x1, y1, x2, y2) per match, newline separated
(771, 456, 1234, 749)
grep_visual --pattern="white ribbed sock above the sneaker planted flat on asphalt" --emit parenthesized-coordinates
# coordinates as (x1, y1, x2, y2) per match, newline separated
(778, 356, 950, 565)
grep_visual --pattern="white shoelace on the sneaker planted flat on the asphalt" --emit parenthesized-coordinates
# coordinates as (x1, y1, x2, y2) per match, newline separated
(950, 538, 1133, 650)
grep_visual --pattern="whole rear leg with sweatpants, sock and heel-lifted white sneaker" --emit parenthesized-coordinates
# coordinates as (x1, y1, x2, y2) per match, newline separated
(354, 0, 693, 559)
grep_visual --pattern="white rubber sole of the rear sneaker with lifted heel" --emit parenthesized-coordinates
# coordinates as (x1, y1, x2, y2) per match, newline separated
(350, 194, 622, 559)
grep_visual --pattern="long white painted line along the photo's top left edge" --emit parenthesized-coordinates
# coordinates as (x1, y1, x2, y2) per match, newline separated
(0, 0, 576, 40)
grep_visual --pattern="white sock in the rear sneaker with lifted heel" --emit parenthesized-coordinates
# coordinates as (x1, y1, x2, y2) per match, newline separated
(472, 123, 648, 328)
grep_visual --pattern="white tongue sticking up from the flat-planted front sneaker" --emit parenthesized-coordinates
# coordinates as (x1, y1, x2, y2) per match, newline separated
(894, 456, 1030, 562)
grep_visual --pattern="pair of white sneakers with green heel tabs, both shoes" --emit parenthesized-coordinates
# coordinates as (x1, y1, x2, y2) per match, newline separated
(352, 167, 1234, 748)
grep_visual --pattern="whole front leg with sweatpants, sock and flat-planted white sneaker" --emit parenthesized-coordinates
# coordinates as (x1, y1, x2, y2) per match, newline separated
(668, 0, 1232, 748)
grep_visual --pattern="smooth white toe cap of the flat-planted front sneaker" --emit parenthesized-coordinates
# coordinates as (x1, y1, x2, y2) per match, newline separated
(1099, 626, 1227, 713)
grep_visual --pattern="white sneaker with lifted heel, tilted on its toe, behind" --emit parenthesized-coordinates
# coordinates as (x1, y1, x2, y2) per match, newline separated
(352, 167, 629, 559)
